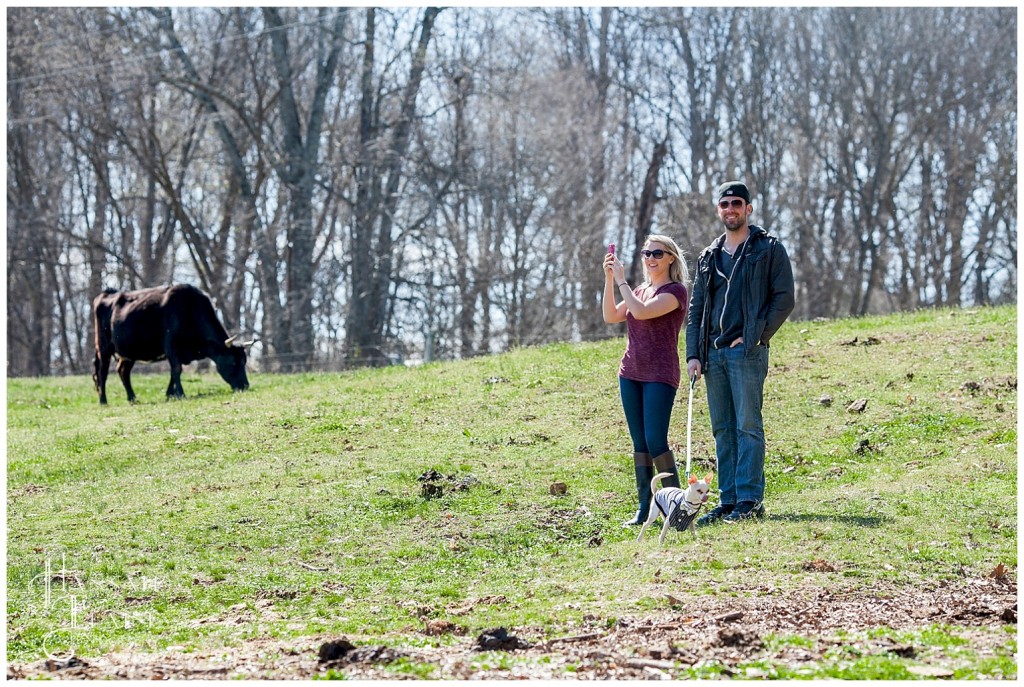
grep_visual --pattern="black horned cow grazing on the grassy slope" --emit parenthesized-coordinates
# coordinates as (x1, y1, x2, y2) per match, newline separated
(92, 285, 249, 403)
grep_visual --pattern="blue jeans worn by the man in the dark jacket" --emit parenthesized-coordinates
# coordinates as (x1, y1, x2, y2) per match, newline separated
(703, 344, 768, 505)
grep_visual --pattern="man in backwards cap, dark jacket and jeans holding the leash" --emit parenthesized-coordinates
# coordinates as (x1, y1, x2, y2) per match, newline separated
(686, 181, 794, 525)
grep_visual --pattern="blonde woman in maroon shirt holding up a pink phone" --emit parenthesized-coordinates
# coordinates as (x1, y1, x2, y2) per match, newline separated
(602, 234, 689, 525)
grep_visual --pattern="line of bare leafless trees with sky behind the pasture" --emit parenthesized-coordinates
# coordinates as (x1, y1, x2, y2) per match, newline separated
(7, 7, 1017, 376)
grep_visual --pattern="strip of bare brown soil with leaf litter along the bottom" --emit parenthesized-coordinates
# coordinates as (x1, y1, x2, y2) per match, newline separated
(7, 577, 1017, 680)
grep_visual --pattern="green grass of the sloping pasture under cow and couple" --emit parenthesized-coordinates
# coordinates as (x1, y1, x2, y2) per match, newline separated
(7, 307, 1017, 679)
